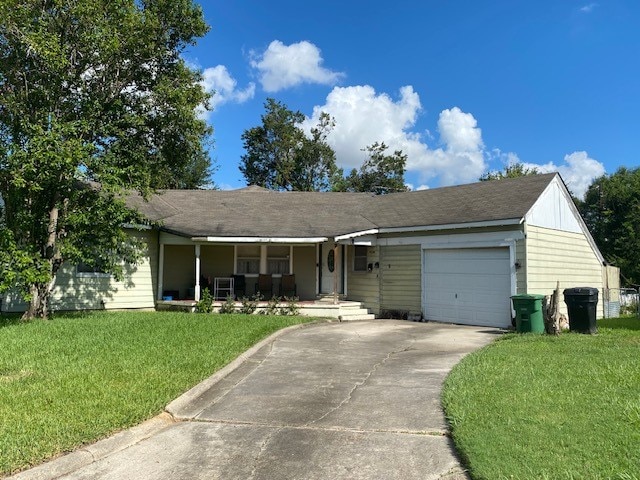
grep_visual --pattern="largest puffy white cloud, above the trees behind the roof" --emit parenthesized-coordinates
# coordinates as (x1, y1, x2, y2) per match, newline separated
(304, 85, 485, 185)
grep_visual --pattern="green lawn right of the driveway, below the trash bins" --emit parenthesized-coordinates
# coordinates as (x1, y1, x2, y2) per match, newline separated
(443, 318, 640, 480)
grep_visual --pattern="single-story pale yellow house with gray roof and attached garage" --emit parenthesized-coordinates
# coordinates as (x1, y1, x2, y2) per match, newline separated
(5, 174, 616, 327)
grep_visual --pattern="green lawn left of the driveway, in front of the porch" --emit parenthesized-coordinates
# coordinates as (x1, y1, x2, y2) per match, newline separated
(0, 312, 309, 474)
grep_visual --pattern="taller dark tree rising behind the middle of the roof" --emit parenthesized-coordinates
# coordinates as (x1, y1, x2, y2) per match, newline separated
(240, 98, 338, 191)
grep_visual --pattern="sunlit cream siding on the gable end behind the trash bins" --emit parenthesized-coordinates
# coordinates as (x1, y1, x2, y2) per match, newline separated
(526, 226, 603, 317)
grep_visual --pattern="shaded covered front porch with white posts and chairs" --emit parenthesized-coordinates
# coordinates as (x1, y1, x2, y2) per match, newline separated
(156, 232, 348, 306)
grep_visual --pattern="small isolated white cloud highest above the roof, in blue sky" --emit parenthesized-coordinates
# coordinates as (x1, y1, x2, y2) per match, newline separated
(251, 40, 344, 92)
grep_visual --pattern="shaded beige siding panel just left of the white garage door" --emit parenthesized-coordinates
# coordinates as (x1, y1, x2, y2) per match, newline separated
(380, 245, 422, 314)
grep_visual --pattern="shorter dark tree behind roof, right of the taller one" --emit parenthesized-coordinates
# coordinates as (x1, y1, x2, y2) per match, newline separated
(334, 142, 407, 194)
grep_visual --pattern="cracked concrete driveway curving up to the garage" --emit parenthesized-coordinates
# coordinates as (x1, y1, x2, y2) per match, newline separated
(15, 320, 499, 480)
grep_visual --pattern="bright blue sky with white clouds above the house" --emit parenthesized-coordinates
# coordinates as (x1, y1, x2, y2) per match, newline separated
(185, 0, 640, 195)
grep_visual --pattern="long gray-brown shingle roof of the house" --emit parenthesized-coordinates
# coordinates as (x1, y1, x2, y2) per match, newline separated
(129, 174, 556, 238)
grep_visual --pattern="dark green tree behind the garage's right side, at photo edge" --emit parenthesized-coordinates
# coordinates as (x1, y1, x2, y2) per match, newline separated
(578, 167, 640, 286)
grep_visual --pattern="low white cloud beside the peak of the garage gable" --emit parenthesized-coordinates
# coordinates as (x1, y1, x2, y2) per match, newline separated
(524, 151, 605, 198)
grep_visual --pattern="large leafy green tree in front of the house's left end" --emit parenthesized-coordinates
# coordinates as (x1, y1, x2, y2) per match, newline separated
(0, 0, 211, 319)
